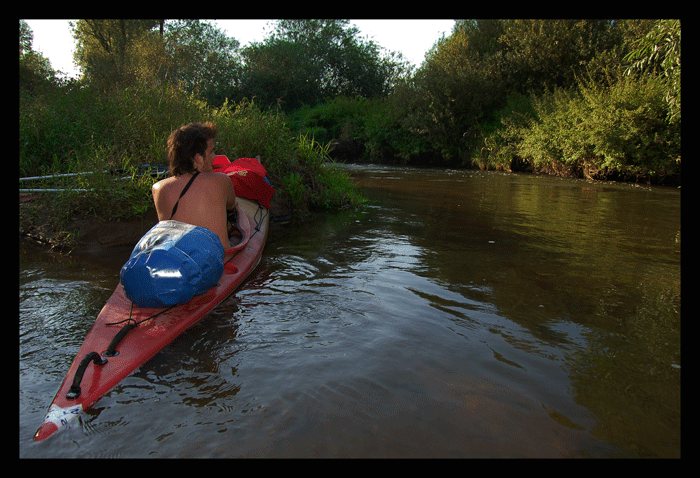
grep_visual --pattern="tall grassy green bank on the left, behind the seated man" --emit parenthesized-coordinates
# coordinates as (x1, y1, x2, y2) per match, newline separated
(19, 83, 362, 250)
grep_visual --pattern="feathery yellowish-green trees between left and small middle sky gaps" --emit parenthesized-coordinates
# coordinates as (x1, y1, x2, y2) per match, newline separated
(73, 19, 241, 106)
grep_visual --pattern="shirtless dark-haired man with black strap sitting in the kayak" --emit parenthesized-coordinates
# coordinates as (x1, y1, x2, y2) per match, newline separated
(152, 123, 236, 249)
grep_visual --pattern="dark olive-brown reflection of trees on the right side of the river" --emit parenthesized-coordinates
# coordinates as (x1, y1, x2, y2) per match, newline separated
(350, 170, 680, 456)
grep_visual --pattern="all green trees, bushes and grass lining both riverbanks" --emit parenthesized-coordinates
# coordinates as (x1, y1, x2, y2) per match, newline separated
(19, 19, 681, 248)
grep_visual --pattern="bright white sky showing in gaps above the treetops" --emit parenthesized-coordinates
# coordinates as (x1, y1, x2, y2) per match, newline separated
(21, 20, 454, 76)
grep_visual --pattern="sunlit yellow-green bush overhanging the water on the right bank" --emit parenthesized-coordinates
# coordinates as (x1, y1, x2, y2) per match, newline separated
(498, 76, 681, 182)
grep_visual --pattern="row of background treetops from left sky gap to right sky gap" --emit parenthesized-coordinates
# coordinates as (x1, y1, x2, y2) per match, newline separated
(65, 19, 407, 111)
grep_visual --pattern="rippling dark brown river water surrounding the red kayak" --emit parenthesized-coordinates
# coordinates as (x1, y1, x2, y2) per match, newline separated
(19, 166, 681, 457)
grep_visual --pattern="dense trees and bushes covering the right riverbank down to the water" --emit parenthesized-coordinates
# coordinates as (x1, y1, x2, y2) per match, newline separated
(282, 19, 681, 186)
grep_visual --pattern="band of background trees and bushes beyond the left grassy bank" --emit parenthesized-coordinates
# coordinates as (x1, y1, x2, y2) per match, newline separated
(20, 19, 681, 184)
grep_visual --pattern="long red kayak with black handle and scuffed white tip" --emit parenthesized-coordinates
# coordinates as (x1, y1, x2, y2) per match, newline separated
(34, 197, 269, 441)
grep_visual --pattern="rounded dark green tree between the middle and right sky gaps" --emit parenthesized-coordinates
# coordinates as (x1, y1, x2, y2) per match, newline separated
(241, 20, 405, 111)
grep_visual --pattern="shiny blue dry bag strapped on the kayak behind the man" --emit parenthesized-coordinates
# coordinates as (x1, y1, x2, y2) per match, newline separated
(119, 220, 224, 307)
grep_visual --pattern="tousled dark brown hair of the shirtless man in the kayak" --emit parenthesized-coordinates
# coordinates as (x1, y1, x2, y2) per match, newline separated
(168, 122, 217, 176)
